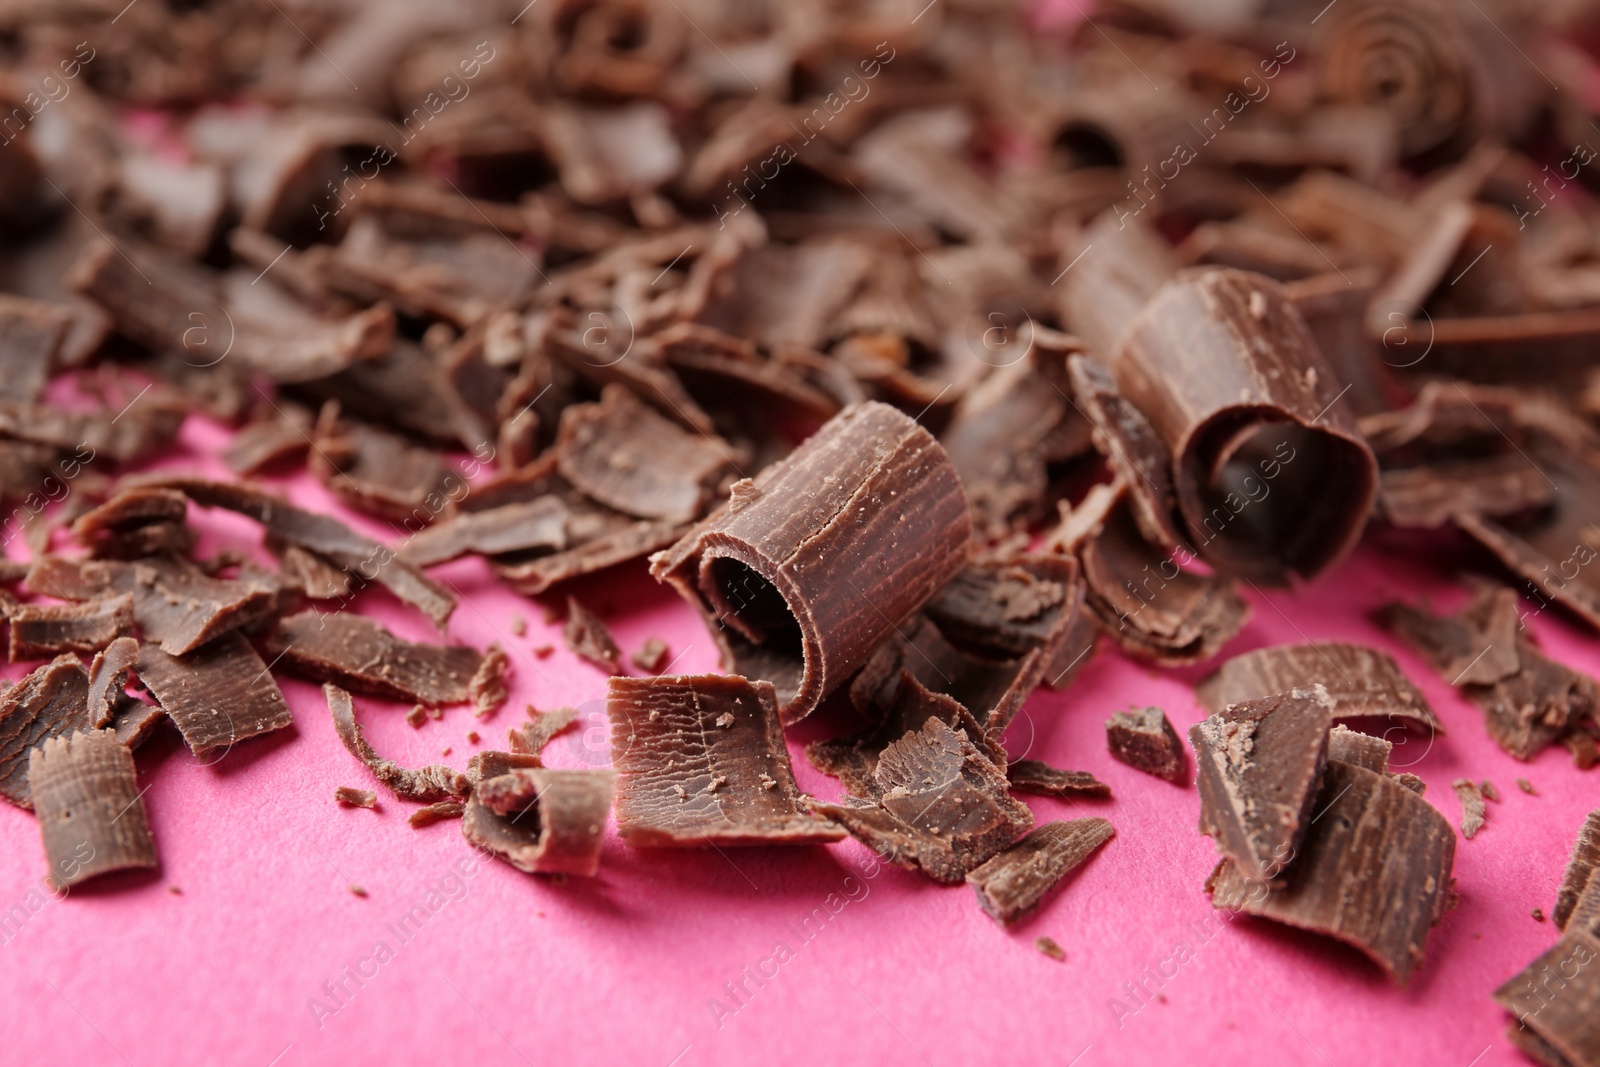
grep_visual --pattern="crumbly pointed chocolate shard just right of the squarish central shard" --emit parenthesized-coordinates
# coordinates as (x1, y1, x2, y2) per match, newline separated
(811, 718, 1034, 885)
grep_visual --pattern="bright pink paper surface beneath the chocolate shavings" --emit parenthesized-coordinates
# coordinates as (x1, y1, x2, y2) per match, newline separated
(0, 418, 1600, 1067)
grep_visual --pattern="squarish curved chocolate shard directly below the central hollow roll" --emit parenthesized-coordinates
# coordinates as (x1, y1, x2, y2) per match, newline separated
(606, 675, 843, 846)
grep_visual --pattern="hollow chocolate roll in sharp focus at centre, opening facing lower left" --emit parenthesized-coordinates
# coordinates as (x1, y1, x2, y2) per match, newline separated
(650, 402, 973, 723)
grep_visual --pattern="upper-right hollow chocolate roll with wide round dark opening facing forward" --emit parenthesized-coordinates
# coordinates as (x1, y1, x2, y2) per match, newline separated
(1110, 267, 1378, 584)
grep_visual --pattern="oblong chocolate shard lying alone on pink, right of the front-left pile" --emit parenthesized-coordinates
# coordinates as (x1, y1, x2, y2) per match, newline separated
(272, 611, 483, 705)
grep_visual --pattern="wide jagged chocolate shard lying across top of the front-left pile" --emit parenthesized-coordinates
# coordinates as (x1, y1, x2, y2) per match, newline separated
(27, 557, 278, 656)
